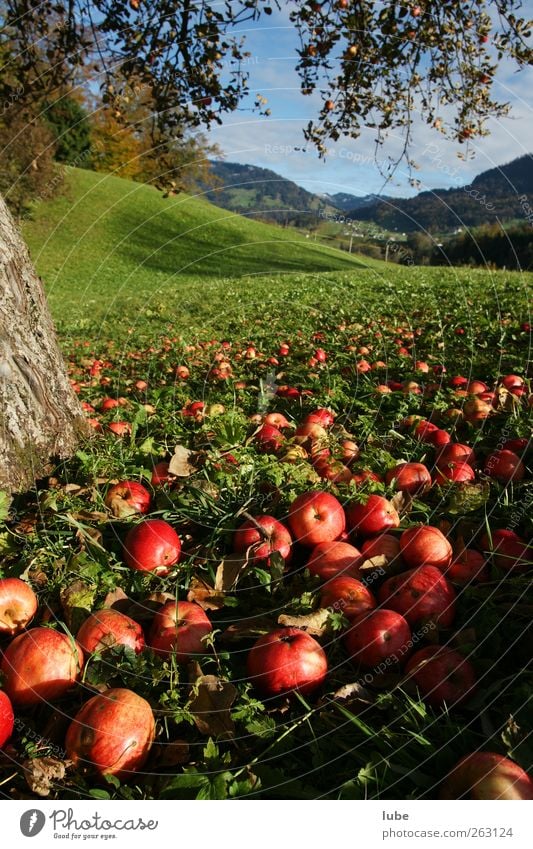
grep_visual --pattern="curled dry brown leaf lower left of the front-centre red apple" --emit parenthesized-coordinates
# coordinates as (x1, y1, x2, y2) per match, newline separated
(189, 675, 237, 737)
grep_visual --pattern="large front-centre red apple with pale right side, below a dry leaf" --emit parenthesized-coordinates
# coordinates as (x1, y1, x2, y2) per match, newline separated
(247, 628, 328, 697)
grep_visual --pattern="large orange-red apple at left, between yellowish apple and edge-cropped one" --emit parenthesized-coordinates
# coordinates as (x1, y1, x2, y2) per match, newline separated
(0, 628, 83, 707)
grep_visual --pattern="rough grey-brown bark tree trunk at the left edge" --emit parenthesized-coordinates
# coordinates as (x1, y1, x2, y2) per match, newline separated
(0, 197, 87, 492)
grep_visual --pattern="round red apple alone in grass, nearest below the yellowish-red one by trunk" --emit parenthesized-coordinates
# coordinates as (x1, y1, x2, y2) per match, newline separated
(124, 519, 181, 577)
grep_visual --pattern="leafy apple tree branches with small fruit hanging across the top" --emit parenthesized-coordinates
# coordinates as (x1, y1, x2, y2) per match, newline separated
(0, 0, 533, 179)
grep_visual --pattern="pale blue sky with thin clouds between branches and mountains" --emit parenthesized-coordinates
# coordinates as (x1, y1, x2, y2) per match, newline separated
(210, 6, 533, 196)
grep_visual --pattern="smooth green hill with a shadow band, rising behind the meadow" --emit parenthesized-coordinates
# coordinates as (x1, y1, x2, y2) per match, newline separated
(23, 168, 379, 327)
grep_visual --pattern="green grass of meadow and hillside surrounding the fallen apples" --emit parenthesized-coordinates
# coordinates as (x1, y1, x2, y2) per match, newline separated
(4, 162, 533, 800)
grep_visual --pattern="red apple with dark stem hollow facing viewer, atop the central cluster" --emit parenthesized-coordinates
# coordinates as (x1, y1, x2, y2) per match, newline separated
(288, 491, 346, 546)
